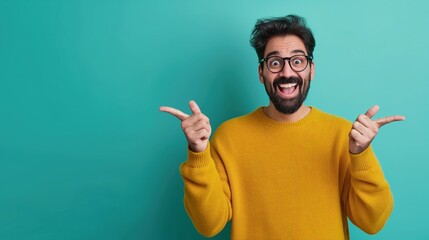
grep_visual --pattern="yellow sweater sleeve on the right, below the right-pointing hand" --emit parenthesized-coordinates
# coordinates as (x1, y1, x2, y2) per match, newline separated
(343, 146, 393, 234)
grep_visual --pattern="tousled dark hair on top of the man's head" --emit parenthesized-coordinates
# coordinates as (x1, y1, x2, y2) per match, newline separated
(250, 15, 316, 60)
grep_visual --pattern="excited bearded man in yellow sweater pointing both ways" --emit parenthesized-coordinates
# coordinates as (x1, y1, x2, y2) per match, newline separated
(160, 15, 405, 240)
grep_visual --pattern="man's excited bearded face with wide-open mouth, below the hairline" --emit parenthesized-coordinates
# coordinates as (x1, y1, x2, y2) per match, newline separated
(259, 35, 314, 114)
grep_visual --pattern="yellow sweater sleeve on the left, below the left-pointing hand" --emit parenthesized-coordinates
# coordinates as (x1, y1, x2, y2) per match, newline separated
(180, 144, 232, 237)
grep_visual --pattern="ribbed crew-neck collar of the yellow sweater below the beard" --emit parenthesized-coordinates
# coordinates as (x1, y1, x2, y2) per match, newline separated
(252, 107, 320, 128)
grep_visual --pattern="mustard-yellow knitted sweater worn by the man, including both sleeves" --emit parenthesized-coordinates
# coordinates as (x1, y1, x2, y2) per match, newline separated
(180, 107, 393, 240)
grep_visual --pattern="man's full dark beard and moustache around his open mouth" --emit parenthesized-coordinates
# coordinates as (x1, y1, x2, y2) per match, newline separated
(264, 74, 310, 114)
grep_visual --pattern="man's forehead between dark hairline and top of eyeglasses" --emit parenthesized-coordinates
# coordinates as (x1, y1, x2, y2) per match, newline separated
(264, 35, 307, 57)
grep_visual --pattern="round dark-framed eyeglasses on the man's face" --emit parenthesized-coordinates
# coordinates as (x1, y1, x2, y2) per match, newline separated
(259, 55, 313, 73)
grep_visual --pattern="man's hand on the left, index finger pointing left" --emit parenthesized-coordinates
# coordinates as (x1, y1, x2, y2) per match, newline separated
(159, 101, 212, 152)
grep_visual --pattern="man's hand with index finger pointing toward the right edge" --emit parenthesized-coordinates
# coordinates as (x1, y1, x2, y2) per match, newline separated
(349, 105, 405, 154)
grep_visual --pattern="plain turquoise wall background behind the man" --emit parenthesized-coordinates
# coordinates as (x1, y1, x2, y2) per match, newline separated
(0, 0, 429, 240)
